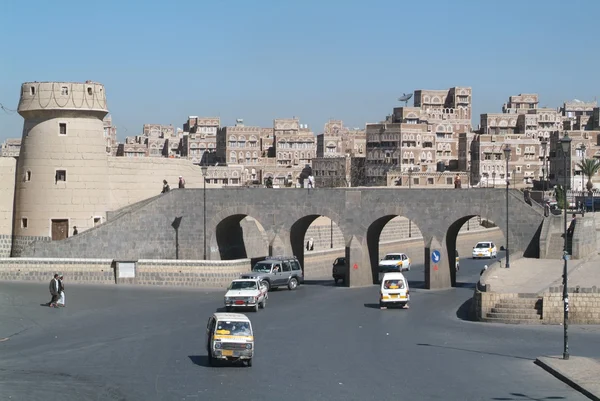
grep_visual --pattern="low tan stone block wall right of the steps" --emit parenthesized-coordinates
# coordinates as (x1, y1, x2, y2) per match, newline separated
(542, 287, 600, 324)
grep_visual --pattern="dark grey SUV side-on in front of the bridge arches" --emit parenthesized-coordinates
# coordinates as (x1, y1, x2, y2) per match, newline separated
(242, 256, 304, 290)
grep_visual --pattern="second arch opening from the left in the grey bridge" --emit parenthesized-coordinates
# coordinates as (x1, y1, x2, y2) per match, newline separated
(290, 215, 346, 282)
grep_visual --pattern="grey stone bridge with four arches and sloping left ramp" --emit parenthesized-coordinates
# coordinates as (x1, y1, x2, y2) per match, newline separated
(20, 188, 544, 289)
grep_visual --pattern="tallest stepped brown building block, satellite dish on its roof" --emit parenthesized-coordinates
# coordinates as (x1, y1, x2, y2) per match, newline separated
(365, 87, 471, 185)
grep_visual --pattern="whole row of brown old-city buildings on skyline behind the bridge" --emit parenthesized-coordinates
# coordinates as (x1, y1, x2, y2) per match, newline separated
(0, 87, 600, 189)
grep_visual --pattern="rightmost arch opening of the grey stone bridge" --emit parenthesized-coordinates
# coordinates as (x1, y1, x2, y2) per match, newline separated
(446, 215, 506, 287)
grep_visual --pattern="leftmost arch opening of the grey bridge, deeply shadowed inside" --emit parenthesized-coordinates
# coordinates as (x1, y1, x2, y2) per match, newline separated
(216, 214, 269, 264)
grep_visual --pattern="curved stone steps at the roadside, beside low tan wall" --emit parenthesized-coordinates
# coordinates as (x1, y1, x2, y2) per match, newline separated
(482, 294, 542, 324)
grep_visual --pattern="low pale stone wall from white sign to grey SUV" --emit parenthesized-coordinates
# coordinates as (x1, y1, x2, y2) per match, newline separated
(135, 259, 251, 288)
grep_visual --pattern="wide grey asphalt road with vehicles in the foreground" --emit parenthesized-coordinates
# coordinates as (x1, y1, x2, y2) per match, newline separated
(0, 260, 600, 401)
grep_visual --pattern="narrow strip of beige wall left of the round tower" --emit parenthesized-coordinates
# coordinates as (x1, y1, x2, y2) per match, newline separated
(0, 157, 17, 258)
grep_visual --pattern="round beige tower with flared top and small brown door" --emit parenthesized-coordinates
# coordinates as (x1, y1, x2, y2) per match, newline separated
(12, 81, 110, 256)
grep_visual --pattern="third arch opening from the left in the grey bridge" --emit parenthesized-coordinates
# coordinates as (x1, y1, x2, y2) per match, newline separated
(367, 215, 425, 284)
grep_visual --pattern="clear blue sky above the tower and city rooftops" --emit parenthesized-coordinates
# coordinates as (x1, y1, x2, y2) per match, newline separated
(0, 0, 600, 140)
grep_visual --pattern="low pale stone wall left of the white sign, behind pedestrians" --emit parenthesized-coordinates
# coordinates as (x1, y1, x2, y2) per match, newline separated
(0, 258, 115, 287)
